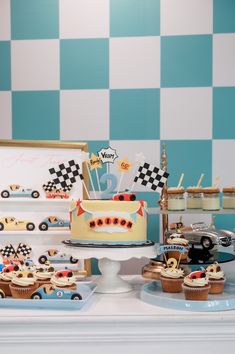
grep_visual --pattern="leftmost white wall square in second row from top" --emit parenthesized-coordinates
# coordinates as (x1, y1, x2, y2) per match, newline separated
(11, 40, 60, 90)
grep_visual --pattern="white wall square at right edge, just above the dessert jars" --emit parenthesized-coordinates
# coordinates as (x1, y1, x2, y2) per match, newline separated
(212, 140, 235, 188)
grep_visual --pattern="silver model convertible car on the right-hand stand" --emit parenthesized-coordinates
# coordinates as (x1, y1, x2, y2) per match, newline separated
(166, 222, 234, 250)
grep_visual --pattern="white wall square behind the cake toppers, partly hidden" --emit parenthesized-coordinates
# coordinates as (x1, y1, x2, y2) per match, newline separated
(110, 140, 160, 192)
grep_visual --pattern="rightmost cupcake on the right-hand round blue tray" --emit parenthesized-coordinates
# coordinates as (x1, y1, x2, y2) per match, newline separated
(206, 262, 225, 294)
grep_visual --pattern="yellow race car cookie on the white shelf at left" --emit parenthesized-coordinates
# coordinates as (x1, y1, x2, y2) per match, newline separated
(0, 216, 35, 231)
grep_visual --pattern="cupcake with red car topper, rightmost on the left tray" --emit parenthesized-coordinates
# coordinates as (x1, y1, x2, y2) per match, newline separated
(51, 269, 77, 290)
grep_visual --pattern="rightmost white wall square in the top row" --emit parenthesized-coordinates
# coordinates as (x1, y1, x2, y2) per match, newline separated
(161, 0, 213, 35)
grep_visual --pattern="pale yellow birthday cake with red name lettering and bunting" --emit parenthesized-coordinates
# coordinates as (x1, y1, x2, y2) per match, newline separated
(70, 200, 147, 245)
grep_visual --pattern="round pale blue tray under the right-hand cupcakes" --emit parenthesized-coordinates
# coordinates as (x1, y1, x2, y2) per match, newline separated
(140, 281, 235, 312)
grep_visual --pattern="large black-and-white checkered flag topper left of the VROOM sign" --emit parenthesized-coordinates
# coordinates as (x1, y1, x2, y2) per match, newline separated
(49, 160, 83, 190)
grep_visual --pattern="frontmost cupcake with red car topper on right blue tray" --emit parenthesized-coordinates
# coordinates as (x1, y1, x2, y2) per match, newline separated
(182, 270, 210, 301)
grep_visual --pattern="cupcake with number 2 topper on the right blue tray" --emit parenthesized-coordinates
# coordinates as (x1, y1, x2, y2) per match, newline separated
(160, 258, 184, 293)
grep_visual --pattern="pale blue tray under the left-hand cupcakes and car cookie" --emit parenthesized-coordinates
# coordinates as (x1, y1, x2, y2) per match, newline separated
(0, 282, 97, 310)
